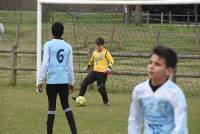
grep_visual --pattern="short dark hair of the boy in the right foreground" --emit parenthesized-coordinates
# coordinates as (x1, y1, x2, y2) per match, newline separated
(152, 45, 178, 68)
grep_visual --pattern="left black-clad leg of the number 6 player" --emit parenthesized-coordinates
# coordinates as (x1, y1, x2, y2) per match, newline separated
(46, 84, 57, 134)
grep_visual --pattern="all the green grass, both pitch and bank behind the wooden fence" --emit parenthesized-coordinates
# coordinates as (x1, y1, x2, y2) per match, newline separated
(0, 12, 200, 134)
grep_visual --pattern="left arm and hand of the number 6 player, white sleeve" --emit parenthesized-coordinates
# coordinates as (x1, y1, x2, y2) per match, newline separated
(37, 45, 49, 92)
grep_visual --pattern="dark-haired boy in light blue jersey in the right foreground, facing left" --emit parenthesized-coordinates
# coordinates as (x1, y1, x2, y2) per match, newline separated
(128, 45, 188, 134)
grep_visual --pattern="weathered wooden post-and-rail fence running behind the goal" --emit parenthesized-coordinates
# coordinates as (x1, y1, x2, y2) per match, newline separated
(0, 45, 200, 85)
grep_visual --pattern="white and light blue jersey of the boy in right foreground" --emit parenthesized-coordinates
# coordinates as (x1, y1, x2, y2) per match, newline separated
(128, 80, 188, 134)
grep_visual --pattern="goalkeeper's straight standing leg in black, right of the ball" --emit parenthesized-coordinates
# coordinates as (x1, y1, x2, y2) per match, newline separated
(97, 73, 109, 105)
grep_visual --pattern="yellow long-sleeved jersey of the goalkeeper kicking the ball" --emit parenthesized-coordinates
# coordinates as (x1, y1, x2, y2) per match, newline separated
(88, 48, 114, 72)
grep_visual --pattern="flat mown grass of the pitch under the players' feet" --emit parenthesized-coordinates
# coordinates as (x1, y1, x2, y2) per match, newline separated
(0, 83, 200, 134)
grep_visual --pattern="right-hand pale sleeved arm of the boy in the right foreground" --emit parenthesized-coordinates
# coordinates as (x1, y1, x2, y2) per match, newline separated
(171, 91, 188, 134)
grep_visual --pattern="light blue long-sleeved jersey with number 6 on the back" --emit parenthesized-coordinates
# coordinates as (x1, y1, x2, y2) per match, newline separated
(38, 39, 74, 84)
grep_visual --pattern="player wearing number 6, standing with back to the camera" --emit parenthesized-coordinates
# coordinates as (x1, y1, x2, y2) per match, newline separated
(37, 22, 77, 134)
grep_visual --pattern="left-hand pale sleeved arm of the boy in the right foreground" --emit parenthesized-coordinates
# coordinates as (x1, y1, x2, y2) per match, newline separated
(128, 89, 143, 134)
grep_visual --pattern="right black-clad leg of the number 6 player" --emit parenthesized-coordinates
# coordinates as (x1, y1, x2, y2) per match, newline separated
(59, 84, 77, 134)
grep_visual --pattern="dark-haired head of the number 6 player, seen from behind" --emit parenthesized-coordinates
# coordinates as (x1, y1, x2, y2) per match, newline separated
(51, 22, 64, 37)
